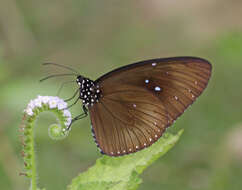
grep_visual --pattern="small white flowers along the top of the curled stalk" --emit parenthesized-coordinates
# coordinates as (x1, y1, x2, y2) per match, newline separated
(24, 96, 71, 126)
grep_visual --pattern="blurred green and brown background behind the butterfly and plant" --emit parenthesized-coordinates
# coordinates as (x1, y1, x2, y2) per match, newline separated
(0, 0, 242, 190)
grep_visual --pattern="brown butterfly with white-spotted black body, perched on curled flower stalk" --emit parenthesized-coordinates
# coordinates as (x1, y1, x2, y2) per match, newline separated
(41, 57, 212, 156)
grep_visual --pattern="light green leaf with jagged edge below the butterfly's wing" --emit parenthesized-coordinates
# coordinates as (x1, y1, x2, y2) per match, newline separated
(68, 130, 183, 190)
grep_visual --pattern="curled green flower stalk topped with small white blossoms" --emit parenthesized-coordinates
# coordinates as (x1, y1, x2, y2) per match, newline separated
(20, 96, 71, 190)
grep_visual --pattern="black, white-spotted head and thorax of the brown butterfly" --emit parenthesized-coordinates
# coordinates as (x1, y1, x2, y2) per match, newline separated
(76, 76, 100, 106)
